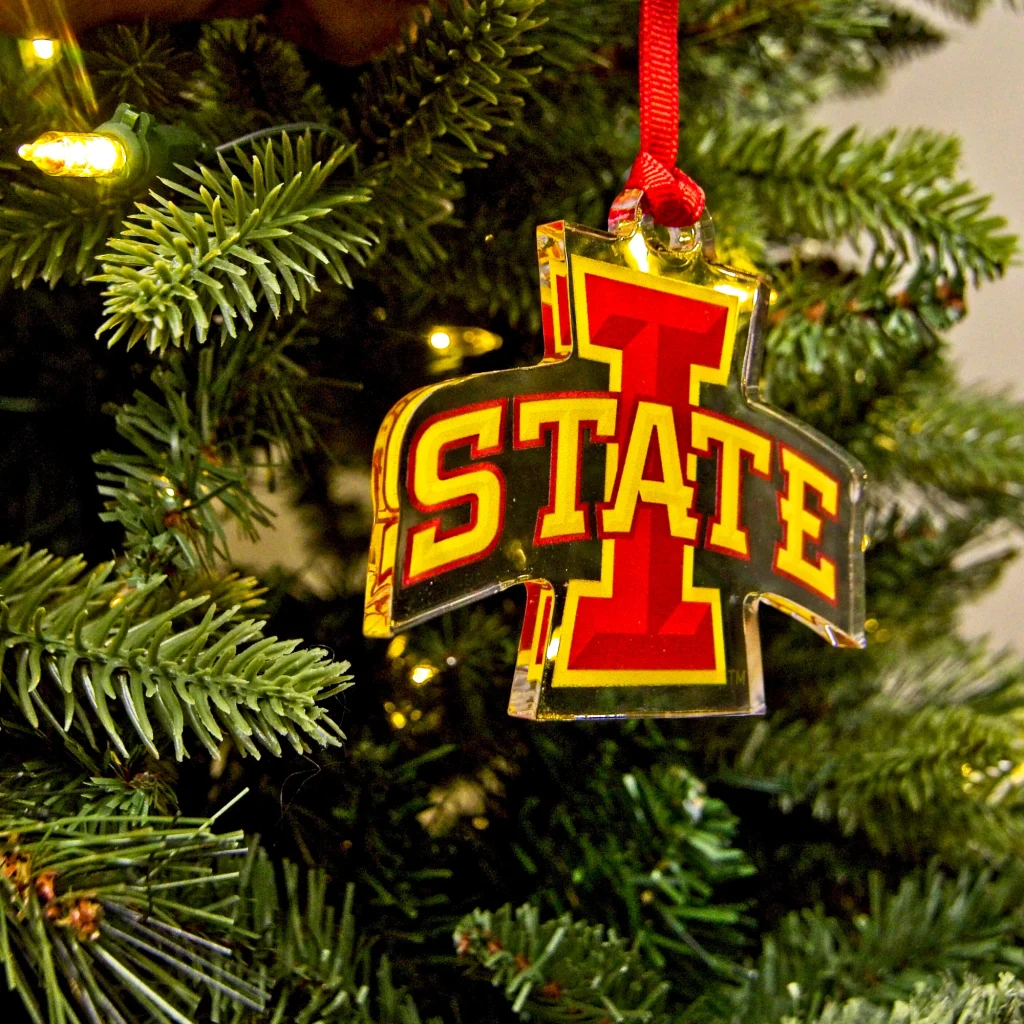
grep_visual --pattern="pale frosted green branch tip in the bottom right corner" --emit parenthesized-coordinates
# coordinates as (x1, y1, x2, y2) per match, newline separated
(817, 974, 1024, 1024)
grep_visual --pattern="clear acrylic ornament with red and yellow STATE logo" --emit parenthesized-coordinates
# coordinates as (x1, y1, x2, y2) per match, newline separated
(365, 190, 864, 719)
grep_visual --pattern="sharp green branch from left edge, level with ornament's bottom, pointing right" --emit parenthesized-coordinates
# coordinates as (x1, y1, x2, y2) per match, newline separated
(0, 547, 348, 760)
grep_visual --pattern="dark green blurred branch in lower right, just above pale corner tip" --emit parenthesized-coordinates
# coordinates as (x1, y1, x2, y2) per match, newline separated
(730, 868, 1024, 1024)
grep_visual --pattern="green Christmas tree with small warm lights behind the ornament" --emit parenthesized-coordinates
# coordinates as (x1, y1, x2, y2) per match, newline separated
(0, 0, 1024, 1024)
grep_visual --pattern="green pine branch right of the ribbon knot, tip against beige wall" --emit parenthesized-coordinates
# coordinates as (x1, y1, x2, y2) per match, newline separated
(693, 125, 1017, 281)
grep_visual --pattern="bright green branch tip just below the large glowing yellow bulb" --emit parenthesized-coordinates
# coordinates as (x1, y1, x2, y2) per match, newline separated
(94, 132, 370, 351)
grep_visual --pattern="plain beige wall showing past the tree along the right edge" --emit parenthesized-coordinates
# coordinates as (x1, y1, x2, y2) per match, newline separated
(816, 3, 1024, 651)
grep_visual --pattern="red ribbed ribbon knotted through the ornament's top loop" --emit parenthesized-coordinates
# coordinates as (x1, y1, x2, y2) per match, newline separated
(626, 0, 705, 227)
